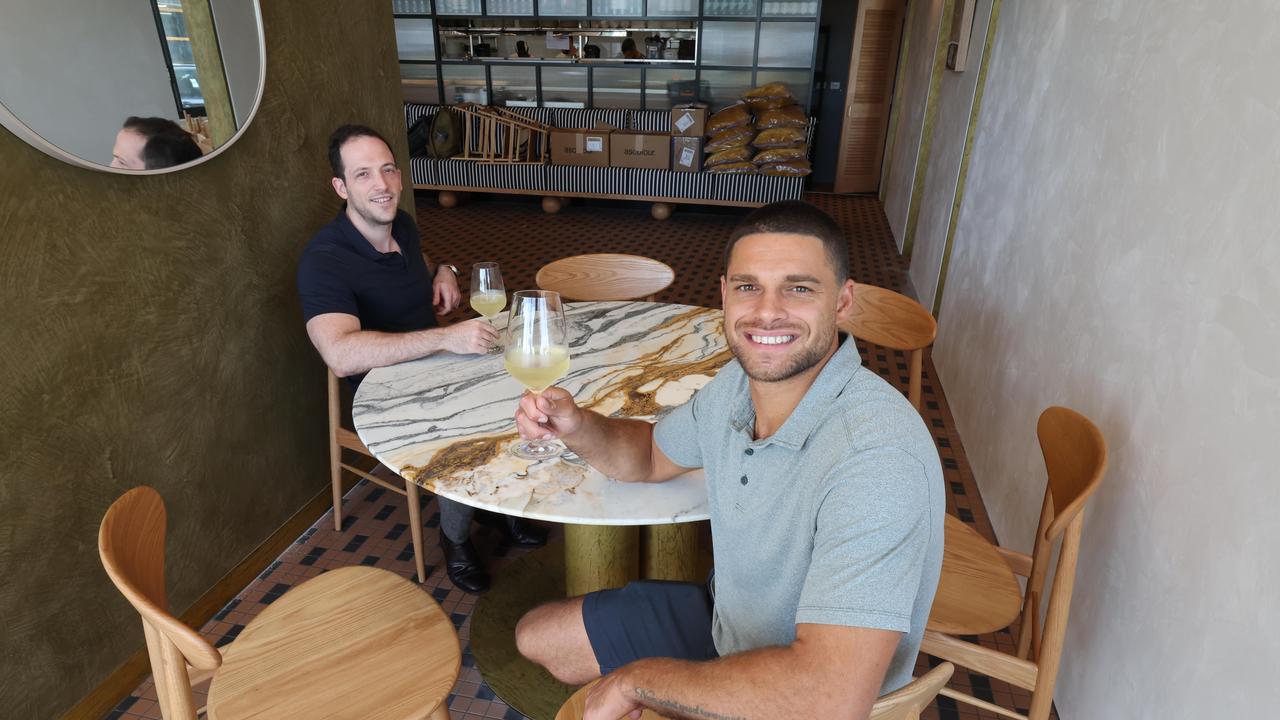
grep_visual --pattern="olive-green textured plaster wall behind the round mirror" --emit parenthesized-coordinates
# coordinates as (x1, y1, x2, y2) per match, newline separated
(0, 0, 411, 717)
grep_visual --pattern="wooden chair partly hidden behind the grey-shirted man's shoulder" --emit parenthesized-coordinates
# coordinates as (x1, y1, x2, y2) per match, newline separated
(841, 283, 938, 410)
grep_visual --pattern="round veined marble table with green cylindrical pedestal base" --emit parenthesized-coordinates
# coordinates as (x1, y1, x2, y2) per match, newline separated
(352, 302, 731, 716)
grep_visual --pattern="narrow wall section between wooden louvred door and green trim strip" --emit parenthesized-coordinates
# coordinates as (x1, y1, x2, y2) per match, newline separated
(881, 0, 946, 250)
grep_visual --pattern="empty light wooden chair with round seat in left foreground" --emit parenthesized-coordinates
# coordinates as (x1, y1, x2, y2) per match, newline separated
(97, 487, 462, 720)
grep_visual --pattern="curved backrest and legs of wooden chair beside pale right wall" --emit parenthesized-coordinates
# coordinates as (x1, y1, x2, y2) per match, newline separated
(920, 407, 1107, 720)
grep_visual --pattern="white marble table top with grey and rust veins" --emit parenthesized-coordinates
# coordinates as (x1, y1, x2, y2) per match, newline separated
(352, 302, 731, 525)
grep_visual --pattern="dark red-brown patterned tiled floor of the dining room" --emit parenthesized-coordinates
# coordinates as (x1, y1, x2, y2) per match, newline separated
(108, 195, 1049, 720)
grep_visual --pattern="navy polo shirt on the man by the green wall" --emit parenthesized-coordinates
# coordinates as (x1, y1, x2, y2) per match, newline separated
(297, 209, 438, 386)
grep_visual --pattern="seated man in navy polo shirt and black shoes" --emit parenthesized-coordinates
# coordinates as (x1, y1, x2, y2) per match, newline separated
(298, 126, 547, 592)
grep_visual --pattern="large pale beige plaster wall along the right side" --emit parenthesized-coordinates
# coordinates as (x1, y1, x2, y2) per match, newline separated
(933, 0, 1280, 720)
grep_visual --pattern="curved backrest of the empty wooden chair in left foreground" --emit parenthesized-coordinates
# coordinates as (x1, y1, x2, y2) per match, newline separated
(97, 486, 223, 720)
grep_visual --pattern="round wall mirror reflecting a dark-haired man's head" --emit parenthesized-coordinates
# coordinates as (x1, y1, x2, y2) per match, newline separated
(0, 0, 266, 174)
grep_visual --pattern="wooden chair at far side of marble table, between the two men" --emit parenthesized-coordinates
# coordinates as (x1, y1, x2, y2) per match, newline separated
(535, 252, 676, 302)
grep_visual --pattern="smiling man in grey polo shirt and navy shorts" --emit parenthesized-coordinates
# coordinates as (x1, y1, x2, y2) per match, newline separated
(516, 202, 945, 720)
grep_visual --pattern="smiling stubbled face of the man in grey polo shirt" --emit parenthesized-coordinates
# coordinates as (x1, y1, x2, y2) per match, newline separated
(721, 233, 852, 382)
